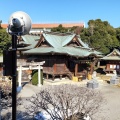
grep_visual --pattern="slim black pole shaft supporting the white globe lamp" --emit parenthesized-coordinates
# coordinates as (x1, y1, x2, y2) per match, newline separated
(12, 35, 17, 120)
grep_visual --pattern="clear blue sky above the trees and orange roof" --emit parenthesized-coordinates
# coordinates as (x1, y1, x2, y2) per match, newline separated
(0, 0, 120, 28)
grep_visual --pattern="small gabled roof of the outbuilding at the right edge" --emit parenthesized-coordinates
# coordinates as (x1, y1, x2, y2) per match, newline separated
(101, 49, 120, 60)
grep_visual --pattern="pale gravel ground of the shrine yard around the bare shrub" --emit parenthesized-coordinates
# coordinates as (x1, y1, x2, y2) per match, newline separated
(18, 76, 120, 120)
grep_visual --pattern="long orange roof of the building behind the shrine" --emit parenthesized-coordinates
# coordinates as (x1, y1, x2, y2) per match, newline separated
(1, 22, 85, 28)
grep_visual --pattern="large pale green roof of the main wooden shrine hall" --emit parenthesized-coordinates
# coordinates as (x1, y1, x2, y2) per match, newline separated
(23, 33, 101, 57)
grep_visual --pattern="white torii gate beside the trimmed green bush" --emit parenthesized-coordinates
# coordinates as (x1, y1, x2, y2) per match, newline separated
(17, 61, 45, 87)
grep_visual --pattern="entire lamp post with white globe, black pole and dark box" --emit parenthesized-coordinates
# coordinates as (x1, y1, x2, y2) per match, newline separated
(3, 11, 31, 120)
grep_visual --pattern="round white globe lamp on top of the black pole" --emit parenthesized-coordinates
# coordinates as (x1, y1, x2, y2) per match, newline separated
(8, 11, 32, 35)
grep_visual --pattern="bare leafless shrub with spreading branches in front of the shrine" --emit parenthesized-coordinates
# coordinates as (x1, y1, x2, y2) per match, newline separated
(26, 85, 103, 120)
